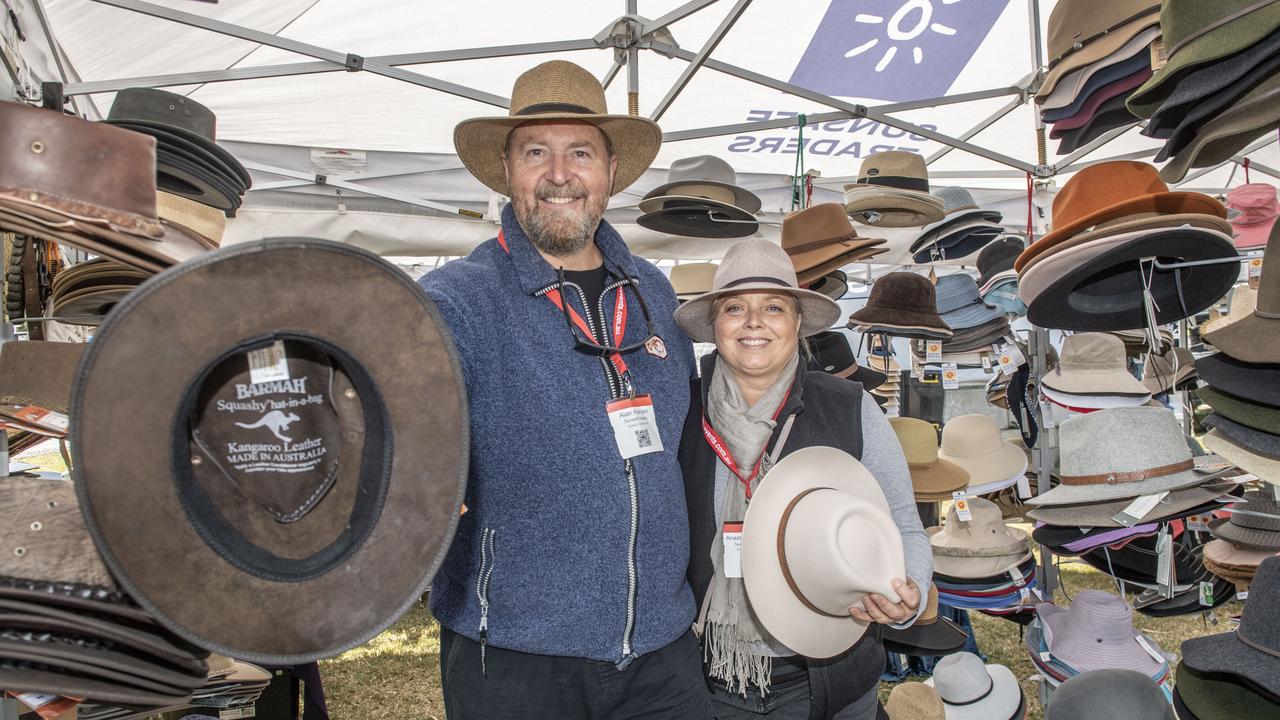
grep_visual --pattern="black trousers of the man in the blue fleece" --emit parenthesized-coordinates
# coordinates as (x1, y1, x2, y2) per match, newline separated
(440, 628, 714, 720)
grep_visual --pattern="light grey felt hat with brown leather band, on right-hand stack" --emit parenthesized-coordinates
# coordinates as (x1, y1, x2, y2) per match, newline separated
(1027, 406, 1206, 505)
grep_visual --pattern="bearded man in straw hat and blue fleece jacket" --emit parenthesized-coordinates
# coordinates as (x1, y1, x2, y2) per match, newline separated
(422, 61, 710, 720)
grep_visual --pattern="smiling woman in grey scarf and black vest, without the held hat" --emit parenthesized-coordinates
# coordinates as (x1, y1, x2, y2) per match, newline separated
(676, 238, 932, 720)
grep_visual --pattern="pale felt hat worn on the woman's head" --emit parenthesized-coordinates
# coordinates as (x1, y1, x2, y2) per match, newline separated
(676, 237, 840, 342)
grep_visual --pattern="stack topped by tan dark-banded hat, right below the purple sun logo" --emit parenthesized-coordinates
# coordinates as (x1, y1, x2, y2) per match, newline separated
(845, 150, 943, 228)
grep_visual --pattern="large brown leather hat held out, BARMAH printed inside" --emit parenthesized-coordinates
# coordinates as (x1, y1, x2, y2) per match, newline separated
(70, 238, 467, 664)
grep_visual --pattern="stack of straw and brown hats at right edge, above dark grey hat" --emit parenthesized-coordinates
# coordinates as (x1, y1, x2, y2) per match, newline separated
(1204, 488, 1280, 589)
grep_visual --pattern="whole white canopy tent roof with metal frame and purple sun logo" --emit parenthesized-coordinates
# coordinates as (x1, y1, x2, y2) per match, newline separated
(0, 0, 1280, 264)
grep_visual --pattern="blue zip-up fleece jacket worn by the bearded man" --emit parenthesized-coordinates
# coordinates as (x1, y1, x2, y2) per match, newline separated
(421, 205, 694, 666)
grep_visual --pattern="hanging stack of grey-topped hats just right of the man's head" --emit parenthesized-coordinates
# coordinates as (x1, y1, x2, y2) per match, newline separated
(636, 155, 760, 238)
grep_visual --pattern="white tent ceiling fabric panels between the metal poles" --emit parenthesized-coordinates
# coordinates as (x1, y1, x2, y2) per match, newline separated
(13, 0, 1280, 257)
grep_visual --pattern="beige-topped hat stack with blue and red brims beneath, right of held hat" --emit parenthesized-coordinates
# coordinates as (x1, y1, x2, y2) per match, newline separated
(928, 497, 1039, 615)
